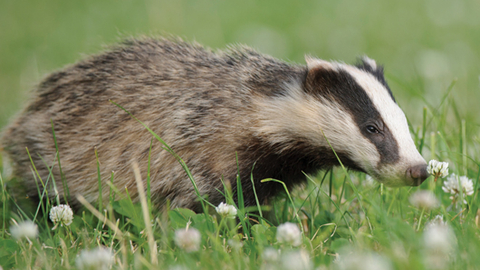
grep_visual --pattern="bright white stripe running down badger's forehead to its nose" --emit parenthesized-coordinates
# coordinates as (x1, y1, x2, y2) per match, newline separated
(342, 65, 424, 169)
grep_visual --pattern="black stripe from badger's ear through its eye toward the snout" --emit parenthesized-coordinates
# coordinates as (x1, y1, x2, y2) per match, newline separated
(306, 69, 399, 164)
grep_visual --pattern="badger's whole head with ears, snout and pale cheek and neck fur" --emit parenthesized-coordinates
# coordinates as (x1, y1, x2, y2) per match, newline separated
(255, 54, 428, 186)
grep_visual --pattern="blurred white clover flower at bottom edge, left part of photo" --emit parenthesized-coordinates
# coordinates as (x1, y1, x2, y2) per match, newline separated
(75, 247, 115, 270)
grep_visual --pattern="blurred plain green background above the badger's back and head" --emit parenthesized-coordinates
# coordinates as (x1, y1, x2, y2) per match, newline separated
(0, 0, 480, 127)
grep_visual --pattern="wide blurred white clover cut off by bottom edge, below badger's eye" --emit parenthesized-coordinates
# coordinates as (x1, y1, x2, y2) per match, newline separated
(335, 248, 393, 270)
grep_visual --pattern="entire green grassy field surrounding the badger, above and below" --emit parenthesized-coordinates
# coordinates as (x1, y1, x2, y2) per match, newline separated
(0, 0, 480, 269)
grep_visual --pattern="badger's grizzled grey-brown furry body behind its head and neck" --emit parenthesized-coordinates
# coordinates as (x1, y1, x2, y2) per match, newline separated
(2, 39, 306, 208)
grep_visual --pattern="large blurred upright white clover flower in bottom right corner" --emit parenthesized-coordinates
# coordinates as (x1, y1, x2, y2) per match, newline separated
(423, 224, 456, 269)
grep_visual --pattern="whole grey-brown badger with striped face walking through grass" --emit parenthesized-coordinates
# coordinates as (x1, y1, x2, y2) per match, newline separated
(1, 38, 428, 210)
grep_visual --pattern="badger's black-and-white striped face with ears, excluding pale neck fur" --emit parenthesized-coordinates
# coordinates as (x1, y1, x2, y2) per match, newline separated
(306, 57, 428, 186)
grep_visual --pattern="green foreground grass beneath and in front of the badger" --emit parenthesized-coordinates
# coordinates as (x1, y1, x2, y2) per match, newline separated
(0, 80, 480, 269)
